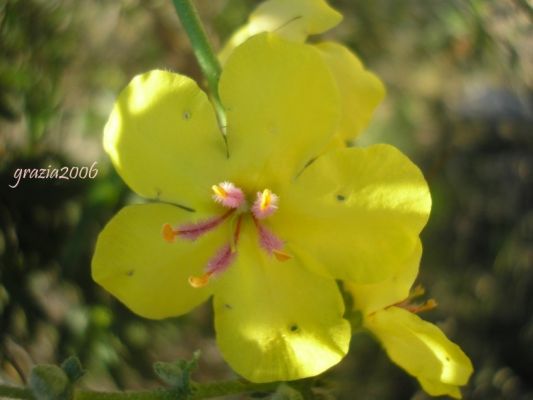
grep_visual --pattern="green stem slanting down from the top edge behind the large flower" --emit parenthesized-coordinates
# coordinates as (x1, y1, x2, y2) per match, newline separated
(172, 0, 226, 133)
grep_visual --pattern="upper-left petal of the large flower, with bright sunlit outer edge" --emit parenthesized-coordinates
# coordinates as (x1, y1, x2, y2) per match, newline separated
(104, 70, 227, 208)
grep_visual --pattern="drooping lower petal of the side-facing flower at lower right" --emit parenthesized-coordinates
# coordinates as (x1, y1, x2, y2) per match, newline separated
(365, 307, 473, 398)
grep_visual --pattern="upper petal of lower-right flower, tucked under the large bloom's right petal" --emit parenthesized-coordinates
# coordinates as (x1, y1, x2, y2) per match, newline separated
(344, 240, 422, 315)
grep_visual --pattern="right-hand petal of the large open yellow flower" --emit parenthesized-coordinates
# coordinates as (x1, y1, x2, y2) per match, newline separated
(271, 145, 431, 283)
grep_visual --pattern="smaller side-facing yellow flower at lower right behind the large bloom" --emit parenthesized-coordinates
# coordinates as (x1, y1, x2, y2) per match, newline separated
(345, 245, 473, 399)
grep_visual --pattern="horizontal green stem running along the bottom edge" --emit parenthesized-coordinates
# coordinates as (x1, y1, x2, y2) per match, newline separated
(0, 381, 279, 400)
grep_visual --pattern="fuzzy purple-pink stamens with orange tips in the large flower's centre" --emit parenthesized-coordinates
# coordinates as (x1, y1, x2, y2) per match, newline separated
(162, 182, 291, 288)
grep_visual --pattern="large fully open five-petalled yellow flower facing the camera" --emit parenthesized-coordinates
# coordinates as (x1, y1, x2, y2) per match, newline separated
(92, 34, 431, 382)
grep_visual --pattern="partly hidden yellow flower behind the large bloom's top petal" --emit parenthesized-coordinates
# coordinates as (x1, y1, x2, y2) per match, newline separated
(220, 0, 385, 144)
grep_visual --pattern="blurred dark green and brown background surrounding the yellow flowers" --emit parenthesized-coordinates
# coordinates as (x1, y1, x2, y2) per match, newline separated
(0, 0, 533, 400)
